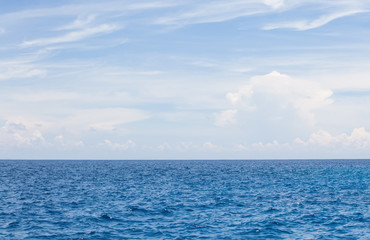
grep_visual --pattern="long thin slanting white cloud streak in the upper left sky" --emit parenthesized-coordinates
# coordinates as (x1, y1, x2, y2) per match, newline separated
(22, 24, 120, 47)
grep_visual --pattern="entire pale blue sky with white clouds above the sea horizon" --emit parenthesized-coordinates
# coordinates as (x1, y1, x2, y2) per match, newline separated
(0, 0, 370, 159)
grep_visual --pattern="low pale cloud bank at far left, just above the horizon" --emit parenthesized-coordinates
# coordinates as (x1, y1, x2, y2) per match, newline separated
(0, 107, 148, 154)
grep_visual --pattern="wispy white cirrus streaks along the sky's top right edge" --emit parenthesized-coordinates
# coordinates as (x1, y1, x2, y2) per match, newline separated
(154, 0, 370, 31)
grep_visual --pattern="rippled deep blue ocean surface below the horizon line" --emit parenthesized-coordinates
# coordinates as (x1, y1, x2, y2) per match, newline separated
(0, 160, 370, 240)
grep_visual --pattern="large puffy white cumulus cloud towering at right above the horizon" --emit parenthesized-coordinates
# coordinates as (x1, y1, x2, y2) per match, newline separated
(221, 71, 332, 124)
